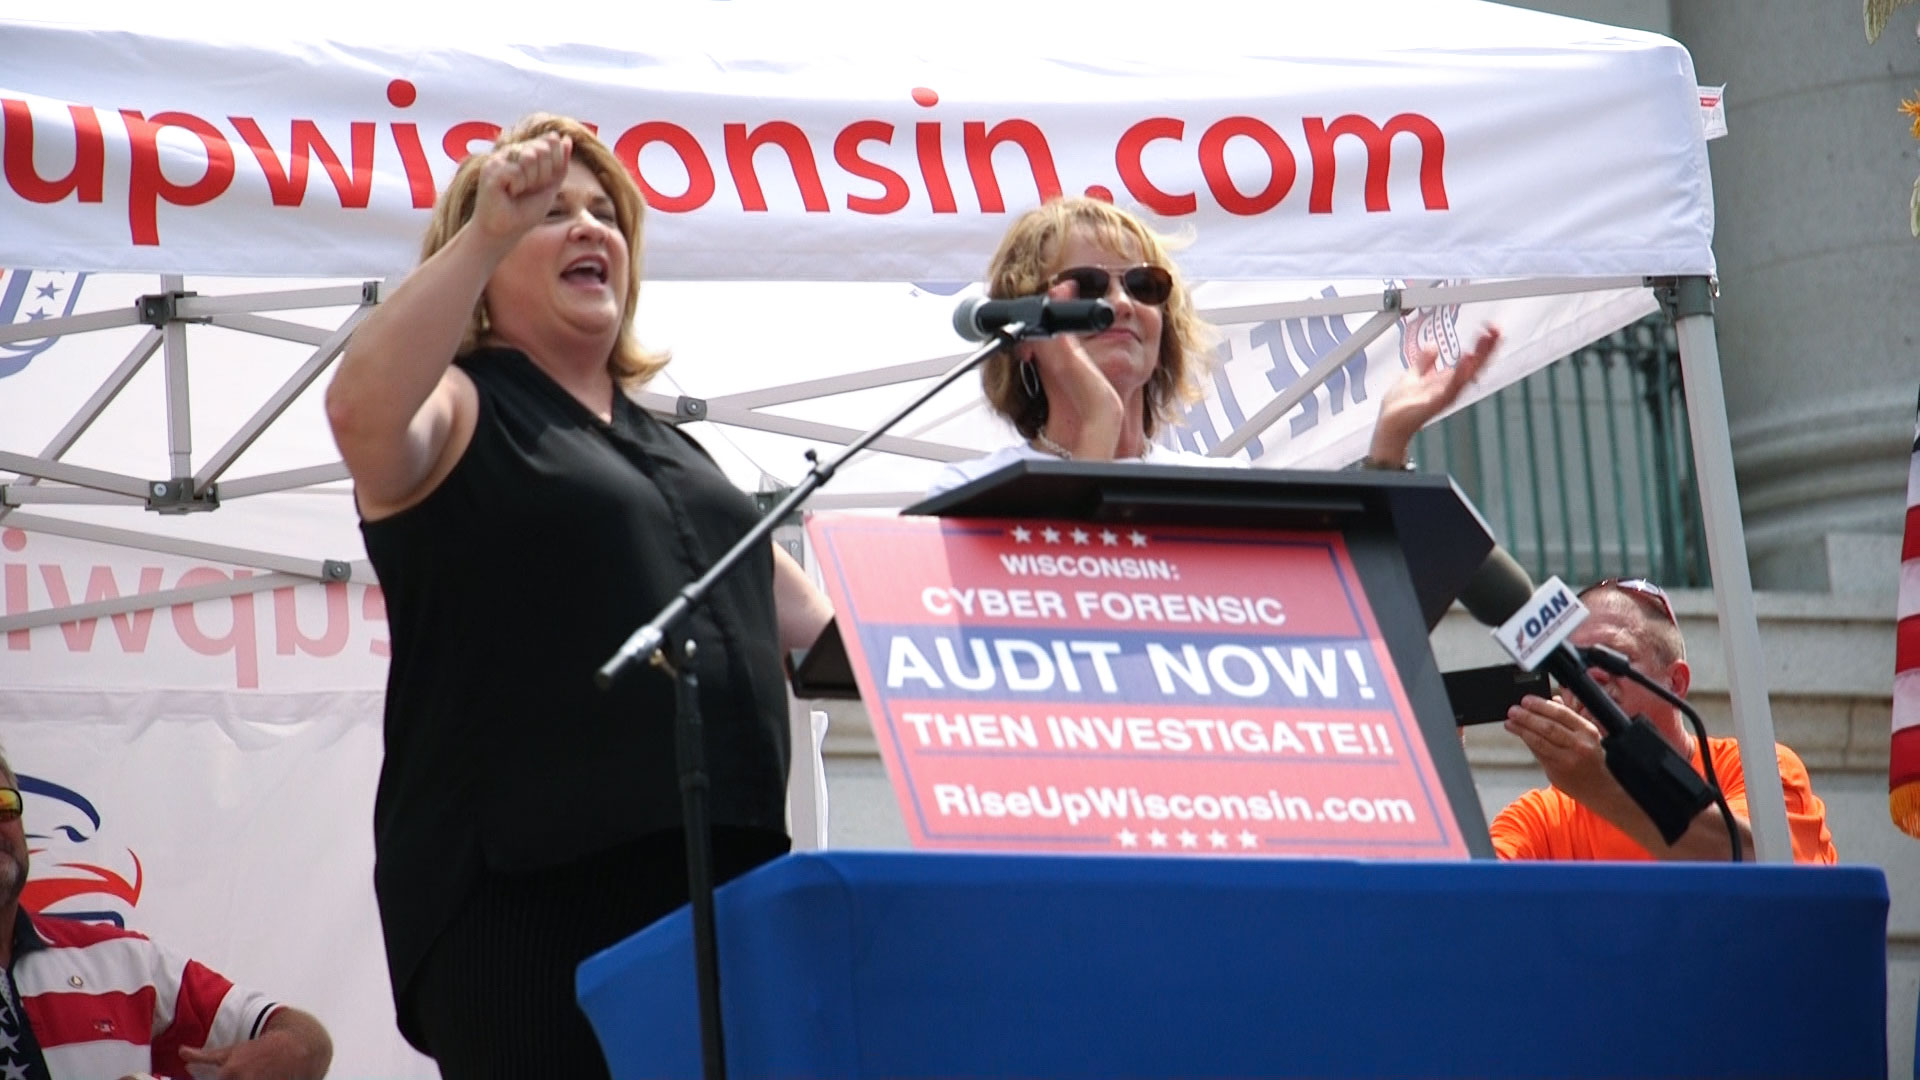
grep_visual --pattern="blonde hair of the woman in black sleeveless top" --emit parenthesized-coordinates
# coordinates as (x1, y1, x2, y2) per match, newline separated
(420, 113, 668, 386)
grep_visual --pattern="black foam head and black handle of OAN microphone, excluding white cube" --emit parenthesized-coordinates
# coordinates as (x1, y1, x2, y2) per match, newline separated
(1459, 548, 1715, 844)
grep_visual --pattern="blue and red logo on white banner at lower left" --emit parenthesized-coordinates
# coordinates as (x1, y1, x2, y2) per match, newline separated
(19, 774, 144, 926)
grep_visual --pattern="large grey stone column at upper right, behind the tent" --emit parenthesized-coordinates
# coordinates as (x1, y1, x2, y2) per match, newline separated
(1670, 0, 1920, 588)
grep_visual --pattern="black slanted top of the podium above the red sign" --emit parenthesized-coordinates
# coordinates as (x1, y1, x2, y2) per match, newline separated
(900, 459, 1494, 630)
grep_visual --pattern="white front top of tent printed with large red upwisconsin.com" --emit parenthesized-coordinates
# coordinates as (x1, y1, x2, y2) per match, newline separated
(0, 0, 1713, 281)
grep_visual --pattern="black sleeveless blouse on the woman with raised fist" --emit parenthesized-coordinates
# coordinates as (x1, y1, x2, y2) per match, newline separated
(361, 350, 789, 988)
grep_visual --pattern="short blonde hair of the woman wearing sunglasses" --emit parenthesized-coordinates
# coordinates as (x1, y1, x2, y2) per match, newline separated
(979, 196, 1213, 438)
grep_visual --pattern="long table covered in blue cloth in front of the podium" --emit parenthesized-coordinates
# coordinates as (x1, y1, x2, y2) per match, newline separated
(578, 853, 1887, 1080)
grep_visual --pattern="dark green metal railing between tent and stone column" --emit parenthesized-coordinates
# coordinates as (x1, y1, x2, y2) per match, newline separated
(1413, 315, 1711, 586)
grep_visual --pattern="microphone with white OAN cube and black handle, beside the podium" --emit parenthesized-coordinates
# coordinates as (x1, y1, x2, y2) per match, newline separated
(1459, 548, 1715, 844)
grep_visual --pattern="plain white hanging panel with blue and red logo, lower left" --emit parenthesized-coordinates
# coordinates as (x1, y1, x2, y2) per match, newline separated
(0, 684, 438, 1078)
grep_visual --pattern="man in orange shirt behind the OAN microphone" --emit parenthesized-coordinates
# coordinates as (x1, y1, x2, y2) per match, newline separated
(1492, 578, 1837, 863)
